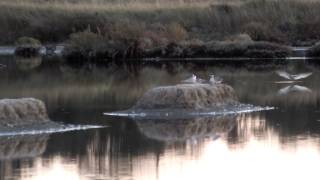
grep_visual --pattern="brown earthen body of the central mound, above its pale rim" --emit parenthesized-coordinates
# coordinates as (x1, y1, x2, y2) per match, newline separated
(133, 83, 238, 110)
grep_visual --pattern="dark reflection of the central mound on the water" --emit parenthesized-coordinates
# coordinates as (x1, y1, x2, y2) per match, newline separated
(135, 116, 236, 141)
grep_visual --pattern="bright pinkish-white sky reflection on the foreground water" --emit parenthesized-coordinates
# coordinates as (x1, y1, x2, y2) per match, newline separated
(23, 116, 320, 180)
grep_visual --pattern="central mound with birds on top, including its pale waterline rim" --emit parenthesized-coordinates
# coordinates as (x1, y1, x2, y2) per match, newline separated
(104, 83, 273, 117)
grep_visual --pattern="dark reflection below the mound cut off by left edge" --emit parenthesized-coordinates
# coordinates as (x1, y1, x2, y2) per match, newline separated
(0, 135, 49, 159)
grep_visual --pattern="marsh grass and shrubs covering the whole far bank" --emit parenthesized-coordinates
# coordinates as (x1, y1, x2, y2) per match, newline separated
(0, 0, 320, 59)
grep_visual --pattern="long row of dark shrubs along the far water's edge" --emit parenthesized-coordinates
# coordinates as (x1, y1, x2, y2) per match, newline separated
(63, 31, 291, 62)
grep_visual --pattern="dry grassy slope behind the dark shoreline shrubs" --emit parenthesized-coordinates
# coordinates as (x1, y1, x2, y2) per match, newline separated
(0, 0, 320, 45)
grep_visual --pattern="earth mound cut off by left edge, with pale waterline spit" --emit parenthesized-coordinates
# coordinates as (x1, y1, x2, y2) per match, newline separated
(0, 98, 102, 134)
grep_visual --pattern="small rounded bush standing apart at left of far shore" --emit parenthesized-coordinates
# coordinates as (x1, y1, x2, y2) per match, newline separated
(15, 37, 41, 57)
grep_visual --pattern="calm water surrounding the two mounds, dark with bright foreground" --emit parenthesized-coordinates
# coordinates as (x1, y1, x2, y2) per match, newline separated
(0, 57, 320, 180)
